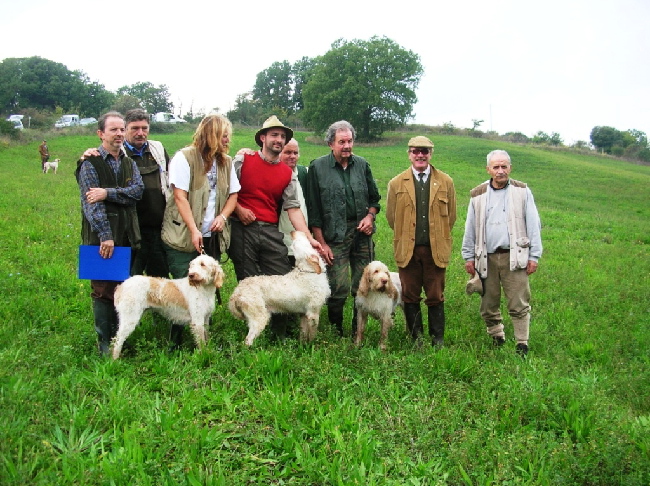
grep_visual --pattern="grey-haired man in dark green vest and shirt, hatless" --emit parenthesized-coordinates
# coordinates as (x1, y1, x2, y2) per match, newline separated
(307, 120, 381, 336)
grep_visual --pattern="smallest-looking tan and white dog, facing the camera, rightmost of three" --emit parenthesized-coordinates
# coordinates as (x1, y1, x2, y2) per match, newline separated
(354, 260, 402, 351)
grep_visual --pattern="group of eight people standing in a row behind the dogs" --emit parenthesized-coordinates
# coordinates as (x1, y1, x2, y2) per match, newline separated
(77, 109, 542, 356)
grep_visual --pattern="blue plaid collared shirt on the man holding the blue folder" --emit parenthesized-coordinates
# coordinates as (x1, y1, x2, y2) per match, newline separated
(79, 145, 144, 241)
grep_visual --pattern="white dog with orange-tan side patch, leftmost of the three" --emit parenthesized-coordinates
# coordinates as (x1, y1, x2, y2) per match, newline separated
(113, 255, 224, 359)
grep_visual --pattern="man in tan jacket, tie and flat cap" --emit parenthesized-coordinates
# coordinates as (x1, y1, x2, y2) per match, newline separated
(386, 136, 456, 346)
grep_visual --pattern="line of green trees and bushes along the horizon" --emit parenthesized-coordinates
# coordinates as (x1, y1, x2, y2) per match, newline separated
(0, 42, 650, 162)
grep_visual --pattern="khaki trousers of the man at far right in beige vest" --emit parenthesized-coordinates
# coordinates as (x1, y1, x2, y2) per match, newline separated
(481, 253, 530, 344)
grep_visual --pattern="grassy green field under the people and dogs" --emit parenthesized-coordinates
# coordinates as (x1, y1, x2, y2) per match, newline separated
(0, 130, 650, 486)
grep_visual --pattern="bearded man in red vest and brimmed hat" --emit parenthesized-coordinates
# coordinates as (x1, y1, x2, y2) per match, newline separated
(228, 115, 322, 337)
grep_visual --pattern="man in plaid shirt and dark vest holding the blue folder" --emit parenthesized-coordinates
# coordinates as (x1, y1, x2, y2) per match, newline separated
(75, 111, 144, 355)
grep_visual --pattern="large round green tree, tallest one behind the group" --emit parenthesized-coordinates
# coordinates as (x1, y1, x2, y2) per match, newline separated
(302, 37, 423, 140)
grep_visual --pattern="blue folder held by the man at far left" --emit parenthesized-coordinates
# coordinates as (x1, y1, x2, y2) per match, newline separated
(79, 245, 131, 282)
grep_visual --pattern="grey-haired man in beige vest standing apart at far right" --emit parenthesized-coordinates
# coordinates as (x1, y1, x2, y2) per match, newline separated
(462, 150, 542, 357)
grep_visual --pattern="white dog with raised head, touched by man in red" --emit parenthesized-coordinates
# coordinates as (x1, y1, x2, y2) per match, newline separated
(228, 231, 330, 346)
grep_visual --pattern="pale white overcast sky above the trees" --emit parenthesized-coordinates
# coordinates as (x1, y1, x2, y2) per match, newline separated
(0, 0, 650, 144)
